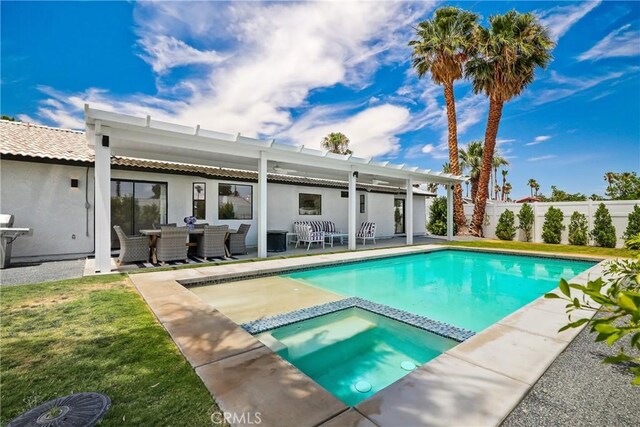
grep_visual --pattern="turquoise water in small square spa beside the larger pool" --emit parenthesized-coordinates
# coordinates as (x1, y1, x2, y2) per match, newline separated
(259, 308, 457, 406)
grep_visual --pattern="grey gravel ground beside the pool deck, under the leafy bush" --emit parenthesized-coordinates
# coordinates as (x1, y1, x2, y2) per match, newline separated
(502, 316, 640, 427)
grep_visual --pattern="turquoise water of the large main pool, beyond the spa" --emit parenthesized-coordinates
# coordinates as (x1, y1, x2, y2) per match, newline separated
(286, 251, 595, 332)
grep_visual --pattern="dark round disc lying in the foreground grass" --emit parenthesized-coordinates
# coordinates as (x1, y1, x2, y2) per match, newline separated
(7, 393, 111, 427)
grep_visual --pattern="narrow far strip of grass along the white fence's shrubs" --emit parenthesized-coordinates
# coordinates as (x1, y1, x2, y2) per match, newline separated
(445, 240, 640, 257)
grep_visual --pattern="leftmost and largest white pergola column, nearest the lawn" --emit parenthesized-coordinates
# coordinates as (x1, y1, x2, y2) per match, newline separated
(94, 122, 111, 273)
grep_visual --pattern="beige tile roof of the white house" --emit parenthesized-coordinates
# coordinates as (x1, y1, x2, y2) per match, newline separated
(0, 120, 430, 194)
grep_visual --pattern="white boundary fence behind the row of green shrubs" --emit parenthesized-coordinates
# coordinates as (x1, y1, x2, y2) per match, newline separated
(427, 199, 640, 247)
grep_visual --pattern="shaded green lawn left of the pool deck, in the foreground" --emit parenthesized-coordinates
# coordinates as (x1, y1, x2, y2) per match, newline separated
(0, 275, 221, 426)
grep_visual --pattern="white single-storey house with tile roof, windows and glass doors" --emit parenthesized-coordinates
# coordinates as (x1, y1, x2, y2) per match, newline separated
(0, 120, 433, 259)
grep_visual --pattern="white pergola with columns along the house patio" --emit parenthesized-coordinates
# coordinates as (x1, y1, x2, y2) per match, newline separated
(85, 105, 465, 273)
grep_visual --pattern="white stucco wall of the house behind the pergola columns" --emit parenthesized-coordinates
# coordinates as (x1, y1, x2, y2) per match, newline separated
(0, 160, 425, 258)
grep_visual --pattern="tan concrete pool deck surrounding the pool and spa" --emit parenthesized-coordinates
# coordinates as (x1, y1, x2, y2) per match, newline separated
(130, 245, 602, 426)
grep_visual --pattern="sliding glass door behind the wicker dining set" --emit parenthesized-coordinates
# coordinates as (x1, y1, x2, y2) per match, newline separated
(111, 179, 167, 248)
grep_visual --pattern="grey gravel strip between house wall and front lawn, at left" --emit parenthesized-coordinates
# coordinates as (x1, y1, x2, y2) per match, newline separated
(0, 259, 86, 286)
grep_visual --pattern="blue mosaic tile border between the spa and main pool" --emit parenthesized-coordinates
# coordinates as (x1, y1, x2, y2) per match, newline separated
(240, 297, 475, 342)
